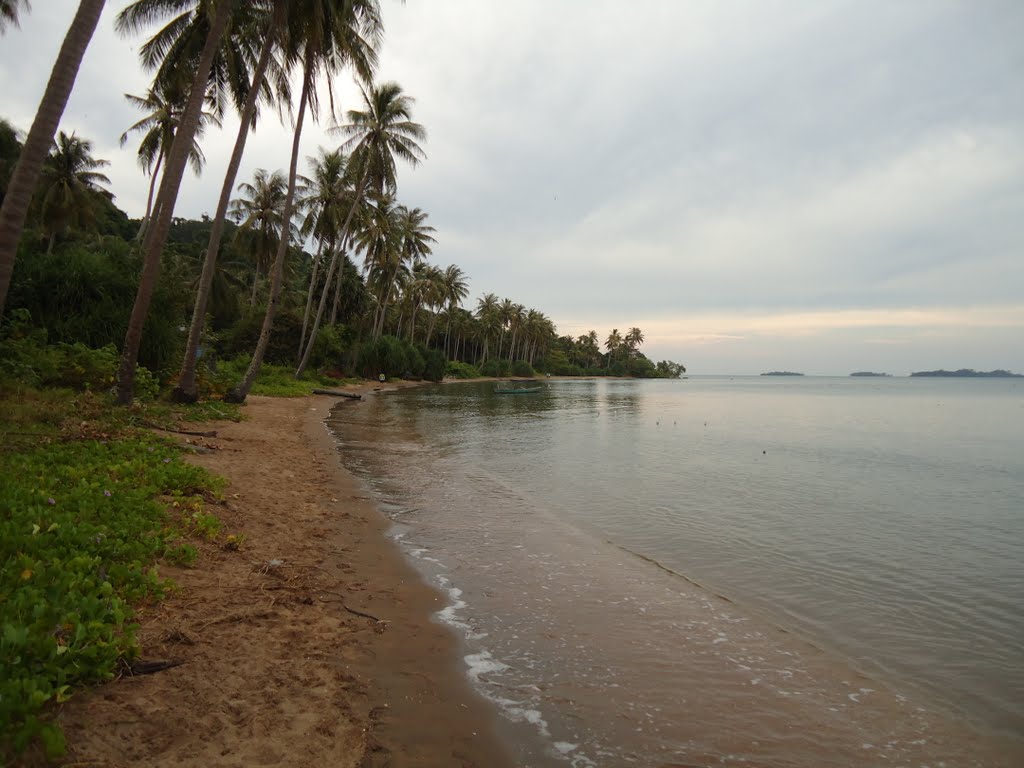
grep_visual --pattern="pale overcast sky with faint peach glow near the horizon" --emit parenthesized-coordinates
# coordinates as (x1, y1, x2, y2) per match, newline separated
(0, 0, 1024, 375)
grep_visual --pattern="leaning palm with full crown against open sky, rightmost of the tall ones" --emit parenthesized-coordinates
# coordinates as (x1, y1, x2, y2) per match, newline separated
(296, 83, 426, 376)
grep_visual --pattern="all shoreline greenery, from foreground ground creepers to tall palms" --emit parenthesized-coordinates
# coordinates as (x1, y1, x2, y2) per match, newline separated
(0, 0, 685, 762)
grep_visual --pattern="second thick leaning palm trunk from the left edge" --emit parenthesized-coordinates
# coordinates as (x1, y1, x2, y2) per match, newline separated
(117, 0, 234, 404)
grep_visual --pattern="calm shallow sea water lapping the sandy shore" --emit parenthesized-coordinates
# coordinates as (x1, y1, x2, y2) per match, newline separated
(330, 377, 1024, 767)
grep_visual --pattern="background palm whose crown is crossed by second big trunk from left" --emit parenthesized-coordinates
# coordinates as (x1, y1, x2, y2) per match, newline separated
(120, 88, 220, 238)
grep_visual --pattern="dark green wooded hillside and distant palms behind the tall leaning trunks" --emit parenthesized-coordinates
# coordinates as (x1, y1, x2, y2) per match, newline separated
(0, 120, 686, 398)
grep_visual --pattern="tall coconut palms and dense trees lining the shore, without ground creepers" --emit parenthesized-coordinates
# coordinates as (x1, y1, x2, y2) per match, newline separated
(0, 0, 685, 403)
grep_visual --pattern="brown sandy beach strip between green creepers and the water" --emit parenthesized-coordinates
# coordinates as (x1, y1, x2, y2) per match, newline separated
(49, 385, 511, 768)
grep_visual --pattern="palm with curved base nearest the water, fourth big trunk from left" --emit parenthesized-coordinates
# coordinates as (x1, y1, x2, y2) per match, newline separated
(226, 0, 383, 402)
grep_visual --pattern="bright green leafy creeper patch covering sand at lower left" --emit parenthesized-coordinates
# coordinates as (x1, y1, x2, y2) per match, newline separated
(0, 433, 221, 760)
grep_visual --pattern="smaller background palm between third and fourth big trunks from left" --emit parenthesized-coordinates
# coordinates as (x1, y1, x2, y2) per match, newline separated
(230, 168, 288, 306)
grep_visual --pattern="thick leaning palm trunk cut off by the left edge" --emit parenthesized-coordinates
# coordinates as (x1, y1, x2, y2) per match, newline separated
(0, 0, 105, 316)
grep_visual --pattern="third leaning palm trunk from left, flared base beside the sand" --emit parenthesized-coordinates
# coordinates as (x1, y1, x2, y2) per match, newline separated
(172, 24, 278, 402)
